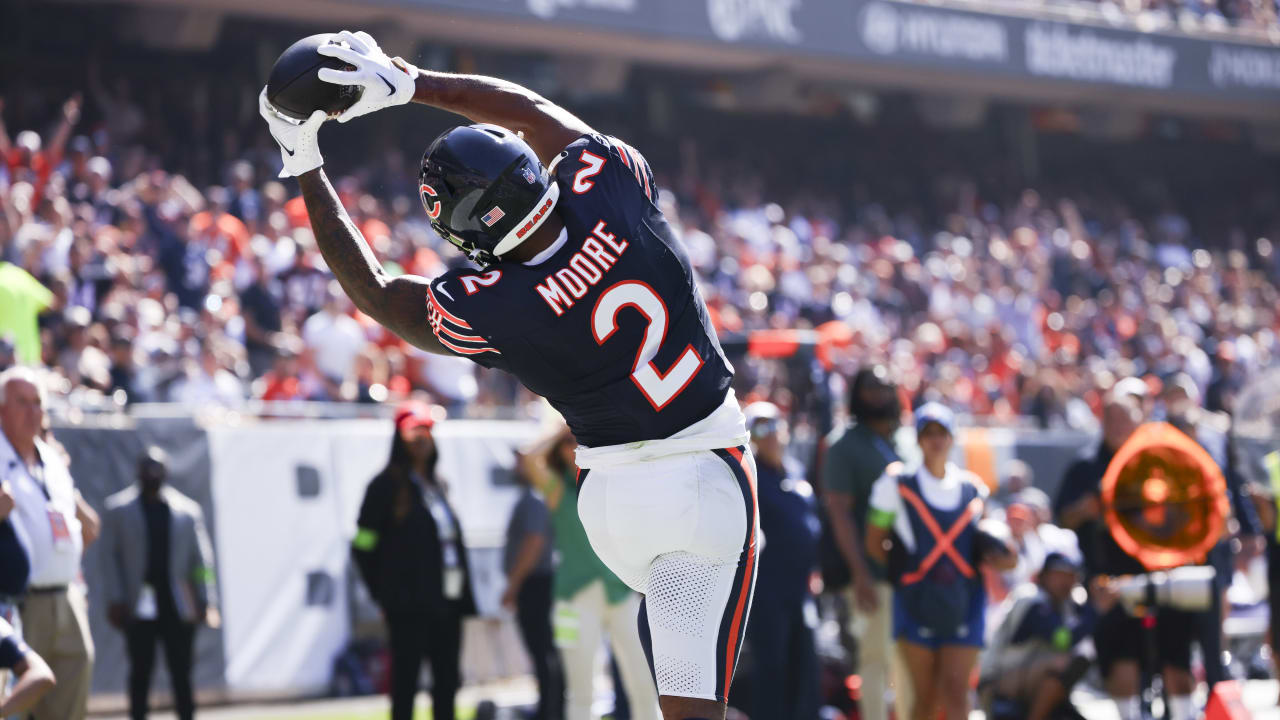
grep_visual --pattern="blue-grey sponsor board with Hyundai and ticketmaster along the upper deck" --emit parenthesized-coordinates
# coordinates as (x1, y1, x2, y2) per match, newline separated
(77, 0, 1280, 123)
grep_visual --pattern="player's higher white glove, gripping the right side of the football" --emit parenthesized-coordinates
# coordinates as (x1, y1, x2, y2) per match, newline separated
(316, 29, 417, 123)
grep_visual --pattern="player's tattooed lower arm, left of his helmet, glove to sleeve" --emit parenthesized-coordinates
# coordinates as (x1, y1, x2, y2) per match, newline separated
(298, 168, 452, 355)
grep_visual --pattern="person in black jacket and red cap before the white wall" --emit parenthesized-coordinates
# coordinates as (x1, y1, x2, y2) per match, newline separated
(352, 404, 476, 720)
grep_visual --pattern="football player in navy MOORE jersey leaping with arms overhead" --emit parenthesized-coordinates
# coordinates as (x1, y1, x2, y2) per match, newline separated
(260, 31, 758, 720)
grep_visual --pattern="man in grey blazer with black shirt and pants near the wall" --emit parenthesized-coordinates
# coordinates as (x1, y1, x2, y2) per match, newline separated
(102, 447, 221, 720)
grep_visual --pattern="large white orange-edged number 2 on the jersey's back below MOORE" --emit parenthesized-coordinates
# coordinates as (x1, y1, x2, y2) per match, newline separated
(591, 281, 703, 410)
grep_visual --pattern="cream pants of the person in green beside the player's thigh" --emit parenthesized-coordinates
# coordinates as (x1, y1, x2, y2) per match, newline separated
(556, 580, 662, 720)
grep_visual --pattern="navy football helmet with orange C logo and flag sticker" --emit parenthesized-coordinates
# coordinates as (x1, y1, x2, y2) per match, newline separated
(417, 124, 559, 265)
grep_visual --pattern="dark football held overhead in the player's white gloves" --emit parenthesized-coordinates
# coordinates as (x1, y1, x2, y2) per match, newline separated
(266, 32, 362, 120)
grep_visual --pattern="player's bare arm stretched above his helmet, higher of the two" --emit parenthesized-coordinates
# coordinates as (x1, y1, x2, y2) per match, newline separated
(413, 73, 593, 163)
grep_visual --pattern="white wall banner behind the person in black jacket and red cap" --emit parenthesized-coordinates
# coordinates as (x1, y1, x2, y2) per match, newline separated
(207, 420, 536, 694)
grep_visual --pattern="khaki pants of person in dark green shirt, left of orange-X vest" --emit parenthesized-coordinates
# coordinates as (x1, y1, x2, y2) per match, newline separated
(845, 582, 911, 720)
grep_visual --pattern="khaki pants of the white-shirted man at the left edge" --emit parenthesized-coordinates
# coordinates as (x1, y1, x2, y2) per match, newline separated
(22, 584, 93, 720)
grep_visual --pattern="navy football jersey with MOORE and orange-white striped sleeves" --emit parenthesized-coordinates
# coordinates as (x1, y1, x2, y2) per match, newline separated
(428, 135, 733, 447)
